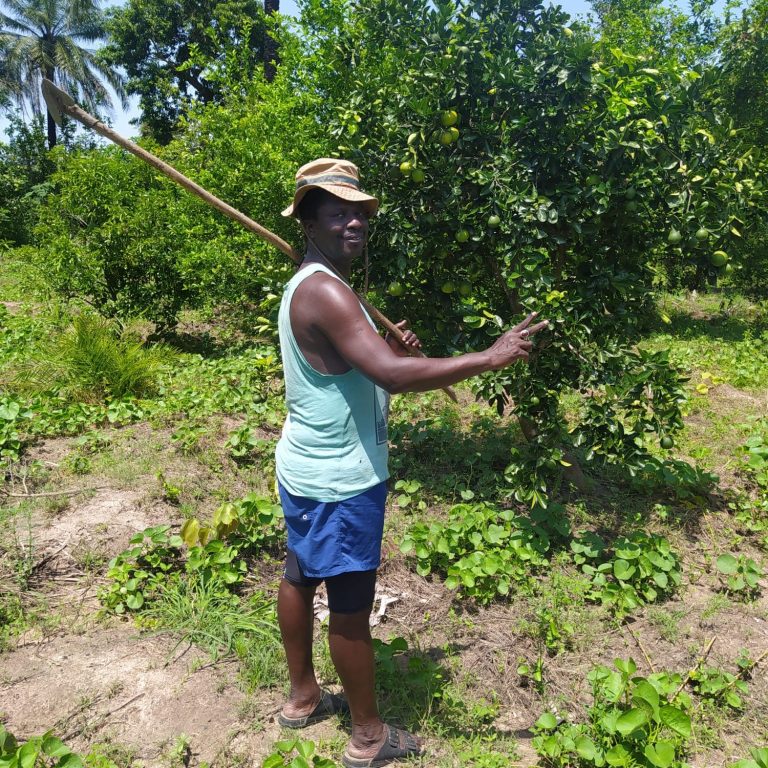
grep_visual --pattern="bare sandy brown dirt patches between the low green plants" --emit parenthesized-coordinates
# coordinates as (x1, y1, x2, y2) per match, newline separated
(0, 428, 768, 768)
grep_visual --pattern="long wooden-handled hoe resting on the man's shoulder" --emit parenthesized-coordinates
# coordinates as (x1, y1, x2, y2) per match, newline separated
(42, 78, 456, 402)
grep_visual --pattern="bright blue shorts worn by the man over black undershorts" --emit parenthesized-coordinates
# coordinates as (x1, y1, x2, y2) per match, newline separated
(278, 482, 387, 579)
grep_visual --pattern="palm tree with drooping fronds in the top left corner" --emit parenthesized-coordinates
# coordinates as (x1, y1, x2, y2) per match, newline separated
(0, 0, 128, 147)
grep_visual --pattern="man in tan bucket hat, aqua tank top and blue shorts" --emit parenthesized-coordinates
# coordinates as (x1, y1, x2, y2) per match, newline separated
(276, 158, 547, 768)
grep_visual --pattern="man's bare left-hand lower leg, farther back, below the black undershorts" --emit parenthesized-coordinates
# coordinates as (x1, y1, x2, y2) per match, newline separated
(277, 579, 322, 717)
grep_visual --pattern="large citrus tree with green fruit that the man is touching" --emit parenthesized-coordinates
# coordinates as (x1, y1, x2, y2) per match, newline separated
(294, 0, 760, 504)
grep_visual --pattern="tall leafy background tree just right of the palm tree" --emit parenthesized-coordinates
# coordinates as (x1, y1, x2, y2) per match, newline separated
(101, 0, 264, 144)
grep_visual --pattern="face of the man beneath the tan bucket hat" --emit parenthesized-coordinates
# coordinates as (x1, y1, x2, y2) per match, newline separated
(304, 194, 368, 262)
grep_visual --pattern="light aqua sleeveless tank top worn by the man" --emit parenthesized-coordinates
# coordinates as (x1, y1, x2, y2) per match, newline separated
(275, 264, 389, 501)
